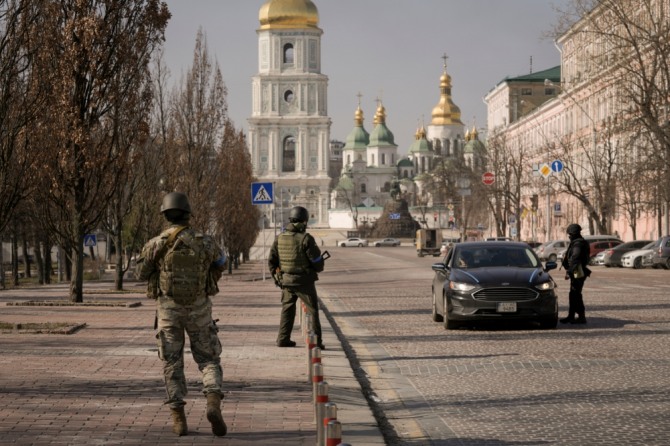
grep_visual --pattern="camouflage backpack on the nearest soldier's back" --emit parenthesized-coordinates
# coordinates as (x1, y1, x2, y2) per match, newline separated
(160, 228, 209, 305)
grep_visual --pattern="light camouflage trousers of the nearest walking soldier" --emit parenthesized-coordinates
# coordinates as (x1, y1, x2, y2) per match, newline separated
(156, 296, 223, 408)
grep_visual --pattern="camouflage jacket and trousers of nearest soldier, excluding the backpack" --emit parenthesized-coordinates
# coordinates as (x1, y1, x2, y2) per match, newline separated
(137, 225, 225, 408)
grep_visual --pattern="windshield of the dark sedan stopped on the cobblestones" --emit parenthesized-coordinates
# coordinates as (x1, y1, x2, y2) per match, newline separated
(453, 246, 540, 269)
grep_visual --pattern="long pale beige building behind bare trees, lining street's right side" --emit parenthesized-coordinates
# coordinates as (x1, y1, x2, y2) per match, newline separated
(485, 0, 670, 241)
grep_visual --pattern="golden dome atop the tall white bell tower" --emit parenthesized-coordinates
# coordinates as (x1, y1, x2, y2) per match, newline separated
(258, 0, 319, 29)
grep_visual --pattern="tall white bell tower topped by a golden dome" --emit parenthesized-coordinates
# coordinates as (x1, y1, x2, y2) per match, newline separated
(248, 0, 331, 227)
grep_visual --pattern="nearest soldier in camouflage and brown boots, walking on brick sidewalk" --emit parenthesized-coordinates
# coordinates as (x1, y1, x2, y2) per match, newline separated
(137, 192, 227, 437)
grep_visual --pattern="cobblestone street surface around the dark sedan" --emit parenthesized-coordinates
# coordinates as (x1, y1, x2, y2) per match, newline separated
(317, 247, 670, 446)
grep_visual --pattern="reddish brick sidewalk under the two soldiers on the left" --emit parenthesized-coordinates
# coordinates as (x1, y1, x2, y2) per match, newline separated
(0, 264, 384, 445)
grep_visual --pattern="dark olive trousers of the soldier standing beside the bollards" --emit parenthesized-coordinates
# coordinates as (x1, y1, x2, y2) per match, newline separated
(277, 282, 323, 345)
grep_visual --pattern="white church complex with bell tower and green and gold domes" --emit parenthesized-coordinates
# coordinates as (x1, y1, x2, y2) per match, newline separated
(248, 0, 488, 228)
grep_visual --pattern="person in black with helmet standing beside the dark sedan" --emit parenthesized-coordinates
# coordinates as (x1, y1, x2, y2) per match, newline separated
(561, 223, 591, 324)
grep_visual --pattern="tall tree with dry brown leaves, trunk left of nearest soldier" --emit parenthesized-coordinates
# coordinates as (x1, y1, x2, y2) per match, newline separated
(36, 0, 170, 302)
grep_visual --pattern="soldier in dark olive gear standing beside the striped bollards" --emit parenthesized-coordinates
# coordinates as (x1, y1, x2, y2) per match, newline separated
(268, 206, 326, 350)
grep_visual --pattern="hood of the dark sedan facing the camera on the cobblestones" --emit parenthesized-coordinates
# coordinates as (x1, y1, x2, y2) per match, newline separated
(451, 267, 551, 286)
